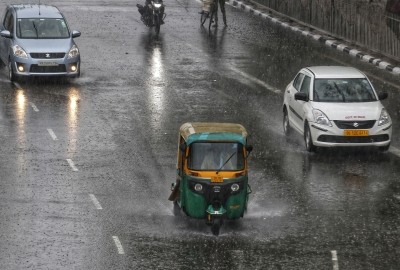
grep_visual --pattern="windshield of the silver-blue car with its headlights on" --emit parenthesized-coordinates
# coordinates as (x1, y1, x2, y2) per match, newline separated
(17, 18, 69, 39)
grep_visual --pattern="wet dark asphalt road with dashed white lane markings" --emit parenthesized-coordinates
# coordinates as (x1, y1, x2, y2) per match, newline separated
(0, 0, 400, 269)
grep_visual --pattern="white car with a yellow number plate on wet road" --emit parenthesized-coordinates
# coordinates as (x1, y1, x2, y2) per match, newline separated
(283, 66, 392, 152)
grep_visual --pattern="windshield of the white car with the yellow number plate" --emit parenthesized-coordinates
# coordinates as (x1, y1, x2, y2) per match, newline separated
(313, 79, 377, 102)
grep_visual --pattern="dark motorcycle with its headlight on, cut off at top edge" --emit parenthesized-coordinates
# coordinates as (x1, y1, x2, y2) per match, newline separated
(136, 0, 167, 35)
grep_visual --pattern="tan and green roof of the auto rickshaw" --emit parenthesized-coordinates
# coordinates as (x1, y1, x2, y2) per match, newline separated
(179, 122, 247, 145)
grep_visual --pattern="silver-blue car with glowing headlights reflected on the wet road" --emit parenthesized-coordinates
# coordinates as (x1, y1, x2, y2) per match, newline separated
(0, 4, 81, 81)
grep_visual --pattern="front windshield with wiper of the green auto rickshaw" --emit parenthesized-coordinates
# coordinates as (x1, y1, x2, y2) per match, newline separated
(188, 142, 244, 171)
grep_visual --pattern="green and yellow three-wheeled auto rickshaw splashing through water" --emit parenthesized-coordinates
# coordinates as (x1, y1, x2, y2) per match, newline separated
(169, 123, 253, 235)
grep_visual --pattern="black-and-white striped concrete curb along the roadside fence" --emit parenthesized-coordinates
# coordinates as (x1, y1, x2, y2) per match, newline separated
(229, 0, 400, 75)
